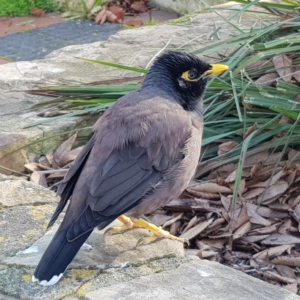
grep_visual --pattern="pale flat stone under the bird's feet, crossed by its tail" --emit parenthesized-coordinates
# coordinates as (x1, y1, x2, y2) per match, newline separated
(2, 221, 184, 269)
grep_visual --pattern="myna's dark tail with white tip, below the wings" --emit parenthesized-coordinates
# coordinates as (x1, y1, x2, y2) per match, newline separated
(32, 224, 93, 286)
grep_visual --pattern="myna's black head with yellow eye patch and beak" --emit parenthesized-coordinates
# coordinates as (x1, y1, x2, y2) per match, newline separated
(143, 51, 227, 111)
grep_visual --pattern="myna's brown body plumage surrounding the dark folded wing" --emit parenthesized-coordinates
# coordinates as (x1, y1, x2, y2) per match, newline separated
(70, 92, 203, 218)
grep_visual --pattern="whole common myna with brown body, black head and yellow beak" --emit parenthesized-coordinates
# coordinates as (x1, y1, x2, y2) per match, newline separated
(32, 51, 227, 286)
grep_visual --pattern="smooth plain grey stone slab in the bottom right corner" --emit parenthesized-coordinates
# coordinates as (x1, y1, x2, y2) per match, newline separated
(84, 258, 299, 300)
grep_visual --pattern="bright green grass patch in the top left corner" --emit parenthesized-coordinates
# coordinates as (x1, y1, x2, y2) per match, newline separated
(0, 0, 59, 17)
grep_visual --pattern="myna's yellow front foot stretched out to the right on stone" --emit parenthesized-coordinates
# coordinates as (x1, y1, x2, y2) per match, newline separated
(133, 219, 187, 246)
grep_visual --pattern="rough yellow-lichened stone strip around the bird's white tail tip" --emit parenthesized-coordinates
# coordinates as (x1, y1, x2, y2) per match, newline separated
(0, 258, 190, 300)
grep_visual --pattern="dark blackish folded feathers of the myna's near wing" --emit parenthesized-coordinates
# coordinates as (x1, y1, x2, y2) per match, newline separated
(67, 145, 178, 241)
